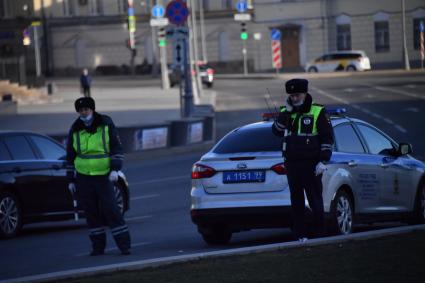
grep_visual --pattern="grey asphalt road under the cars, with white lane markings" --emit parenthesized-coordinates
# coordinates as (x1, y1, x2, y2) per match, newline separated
(0, 73, 425, 280)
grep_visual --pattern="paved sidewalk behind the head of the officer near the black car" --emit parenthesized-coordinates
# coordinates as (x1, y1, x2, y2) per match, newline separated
(0, 77, 211, 135)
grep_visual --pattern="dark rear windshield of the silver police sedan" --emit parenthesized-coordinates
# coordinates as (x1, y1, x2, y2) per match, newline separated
(213, 126, 282, 154)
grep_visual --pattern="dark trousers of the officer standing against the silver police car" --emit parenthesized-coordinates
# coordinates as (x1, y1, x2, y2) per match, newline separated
(285, 161, 325, 238)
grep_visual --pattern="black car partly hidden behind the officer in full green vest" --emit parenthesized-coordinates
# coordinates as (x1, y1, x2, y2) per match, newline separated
(0, 131, 129, 238)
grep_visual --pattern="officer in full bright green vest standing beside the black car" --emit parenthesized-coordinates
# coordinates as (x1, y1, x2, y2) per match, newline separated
(67, 97, 130, 256)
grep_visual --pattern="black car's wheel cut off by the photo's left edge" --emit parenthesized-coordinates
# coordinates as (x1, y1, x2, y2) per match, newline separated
(0, 192, 22, 238)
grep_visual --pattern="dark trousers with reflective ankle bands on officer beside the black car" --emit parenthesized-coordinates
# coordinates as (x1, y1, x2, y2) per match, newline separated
(76, 174, 131, 251)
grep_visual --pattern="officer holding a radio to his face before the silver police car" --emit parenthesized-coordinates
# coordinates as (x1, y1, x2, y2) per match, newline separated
(272, 79, 334, 242)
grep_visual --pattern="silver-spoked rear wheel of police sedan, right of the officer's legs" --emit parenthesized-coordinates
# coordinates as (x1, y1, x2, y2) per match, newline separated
(331, 191, 354, 235)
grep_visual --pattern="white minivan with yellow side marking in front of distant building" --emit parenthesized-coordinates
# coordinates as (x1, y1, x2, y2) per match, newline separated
(305, 50, 371, 73)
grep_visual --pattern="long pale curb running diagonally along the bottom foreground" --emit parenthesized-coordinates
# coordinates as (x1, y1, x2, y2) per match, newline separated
(4, 224, 425, 283)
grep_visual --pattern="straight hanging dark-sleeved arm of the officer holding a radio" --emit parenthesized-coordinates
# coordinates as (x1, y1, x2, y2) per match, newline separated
(317, 109, 334, 162)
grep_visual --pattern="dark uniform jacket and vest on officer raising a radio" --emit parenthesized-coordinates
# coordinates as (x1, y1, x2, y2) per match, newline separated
(272, 93, 334, 163)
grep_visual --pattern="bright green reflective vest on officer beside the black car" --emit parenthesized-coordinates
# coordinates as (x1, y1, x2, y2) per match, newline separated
(73, 126, 111, 176)
